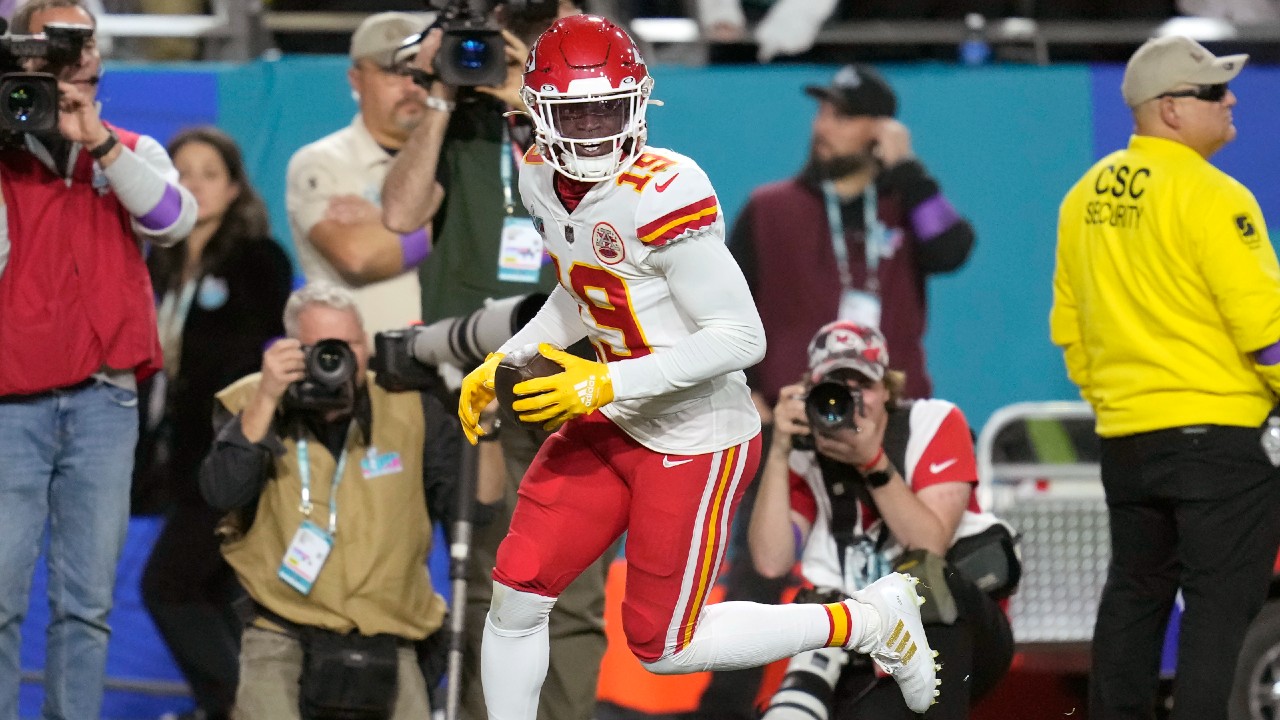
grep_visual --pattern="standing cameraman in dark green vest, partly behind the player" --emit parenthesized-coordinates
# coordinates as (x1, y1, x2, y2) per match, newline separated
(383, 0, 613, 720)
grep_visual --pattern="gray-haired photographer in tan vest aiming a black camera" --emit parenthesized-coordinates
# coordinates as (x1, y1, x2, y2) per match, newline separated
(200, 283, 486, 720)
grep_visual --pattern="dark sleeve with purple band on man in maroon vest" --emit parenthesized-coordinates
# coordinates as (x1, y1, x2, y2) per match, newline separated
(881, 160, 974, 274)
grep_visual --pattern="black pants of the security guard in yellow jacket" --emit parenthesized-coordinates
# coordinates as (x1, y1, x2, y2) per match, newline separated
(1089, 425, 1280, 720)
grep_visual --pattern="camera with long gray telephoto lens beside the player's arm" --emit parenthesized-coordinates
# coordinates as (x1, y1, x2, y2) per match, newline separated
(372, 292, 547, 392)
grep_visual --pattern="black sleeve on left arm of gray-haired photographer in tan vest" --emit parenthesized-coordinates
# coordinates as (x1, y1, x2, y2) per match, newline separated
(200, 405, 284, 510)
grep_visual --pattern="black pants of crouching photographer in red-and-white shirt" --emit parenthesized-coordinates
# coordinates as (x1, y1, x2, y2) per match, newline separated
(831, 568, 1014, 720)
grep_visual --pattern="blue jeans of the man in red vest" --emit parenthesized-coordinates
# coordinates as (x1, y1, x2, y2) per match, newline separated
(0, 382, 138, 720)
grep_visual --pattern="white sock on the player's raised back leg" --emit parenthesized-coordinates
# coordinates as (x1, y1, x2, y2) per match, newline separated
(646, 594, 876, 674)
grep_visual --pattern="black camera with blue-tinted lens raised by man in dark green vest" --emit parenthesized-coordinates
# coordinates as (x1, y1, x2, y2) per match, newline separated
(406, 0, 559, 87)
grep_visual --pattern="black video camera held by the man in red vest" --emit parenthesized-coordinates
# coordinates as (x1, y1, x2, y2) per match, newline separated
(0, 18, 93, 136)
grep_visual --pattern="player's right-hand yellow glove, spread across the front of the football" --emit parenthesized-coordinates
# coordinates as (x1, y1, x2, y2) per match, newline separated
(509, 342, 613, 430)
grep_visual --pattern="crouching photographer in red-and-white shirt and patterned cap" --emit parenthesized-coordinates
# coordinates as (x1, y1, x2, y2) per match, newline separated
(749, 322, 1012, 720)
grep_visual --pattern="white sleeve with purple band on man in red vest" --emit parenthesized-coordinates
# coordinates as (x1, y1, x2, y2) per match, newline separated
(102, 135, 196, 246)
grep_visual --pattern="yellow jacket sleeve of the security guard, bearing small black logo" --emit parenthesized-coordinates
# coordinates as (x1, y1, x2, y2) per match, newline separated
(1192, 184, 1280, 391)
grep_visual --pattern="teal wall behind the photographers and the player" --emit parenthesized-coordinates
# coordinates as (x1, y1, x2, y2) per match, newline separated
(99, 56, 1172, 427)
